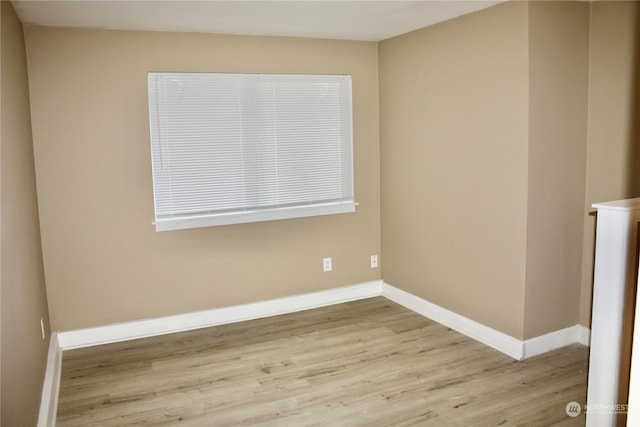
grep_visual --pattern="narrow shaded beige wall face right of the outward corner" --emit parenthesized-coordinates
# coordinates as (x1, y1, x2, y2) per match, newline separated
(524, 1, 589, 339)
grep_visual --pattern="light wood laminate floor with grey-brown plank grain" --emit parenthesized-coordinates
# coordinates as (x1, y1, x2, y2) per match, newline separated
(57, 297, 588, 427)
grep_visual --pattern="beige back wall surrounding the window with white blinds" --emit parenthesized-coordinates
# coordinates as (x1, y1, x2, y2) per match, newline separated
(26, 28, 380, 330)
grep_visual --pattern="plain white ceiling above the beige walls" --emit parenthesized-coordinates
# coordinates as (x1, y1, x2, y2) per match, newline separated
(12, 0, 503, 41)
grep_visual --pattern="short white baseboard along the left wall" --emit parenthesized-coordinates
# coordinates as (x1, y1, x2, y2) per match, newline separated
(38, 332, 62, 427)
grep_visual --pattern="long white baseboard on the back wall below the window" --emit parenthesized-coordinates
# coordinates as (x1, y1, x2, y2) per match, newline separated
(58, 280, 382, 350)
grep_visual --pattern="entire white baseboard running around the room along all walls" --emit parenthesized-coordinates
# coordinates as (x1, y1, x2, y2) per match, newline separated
(38, 280, 589, 427)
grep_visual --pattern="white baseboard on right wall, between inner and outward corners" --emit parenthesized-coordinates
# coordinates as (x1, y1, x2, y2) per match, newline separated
(382, 283, 524, 360)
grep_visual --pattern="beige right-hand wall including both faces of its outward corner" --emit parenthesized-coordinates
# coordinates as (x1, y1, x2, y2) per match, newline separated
(379, 2, 604, 339)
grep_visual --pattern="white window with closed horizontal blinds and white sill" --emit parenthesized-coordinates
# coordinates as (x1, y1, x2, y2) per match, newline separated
(148, 73, 355, 231)
